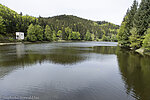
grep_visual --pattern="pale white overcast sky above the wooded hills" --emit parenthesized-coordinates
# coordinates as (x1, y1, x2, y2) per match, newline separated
(0, 0, 141, 25)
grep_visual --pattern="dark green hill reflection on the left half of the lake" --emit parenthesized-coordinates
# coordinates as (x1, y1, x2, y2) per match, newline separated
(0, 45, 85, 67)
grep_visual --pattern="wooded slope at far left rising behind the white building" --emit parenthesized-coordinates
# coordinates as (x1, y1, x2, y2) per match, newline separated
(0, 4, 38, 38)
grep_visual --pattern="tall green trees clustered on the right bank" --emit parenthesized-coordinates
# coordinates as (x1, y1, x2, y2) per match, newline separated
(117, 0, 150, 50)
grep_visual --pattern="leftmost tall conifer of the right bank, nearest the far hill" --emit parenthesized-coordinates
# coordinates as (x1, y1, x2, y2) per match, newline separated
(117, 0, 138, 47)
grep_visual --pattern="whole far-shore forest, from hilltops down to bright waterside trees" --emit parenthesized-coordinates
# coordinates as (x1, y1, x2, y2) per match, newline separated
(0, 4, 119, 41)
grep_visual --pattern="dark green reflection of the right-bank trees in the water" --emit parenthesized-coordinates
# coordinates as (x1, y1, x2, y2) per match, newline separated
(117, 50, 150, 100)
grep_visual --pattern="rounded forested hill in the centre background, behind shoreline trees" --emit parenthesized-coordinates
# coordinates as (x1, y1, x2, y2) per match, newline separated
(39, 15, 119, 39)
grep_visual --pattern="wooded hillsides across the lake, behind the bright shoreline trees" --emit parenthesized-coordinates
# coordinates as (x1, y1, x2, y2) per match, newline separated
(0, 4, 119, 40)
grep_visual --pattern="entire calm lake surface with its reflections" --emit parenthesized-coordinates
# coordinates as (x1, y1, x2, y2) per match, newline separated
(0, 42, 150, 100)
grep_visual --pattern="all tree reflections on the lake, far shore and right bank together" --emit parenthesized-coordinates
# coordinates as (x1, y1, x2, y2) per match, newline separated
(0, 44, 150, 100)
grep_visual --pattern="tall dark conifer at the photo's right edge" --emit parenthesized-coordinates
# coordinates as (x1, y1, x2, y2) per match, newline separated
(131, 0, 150, 48)
